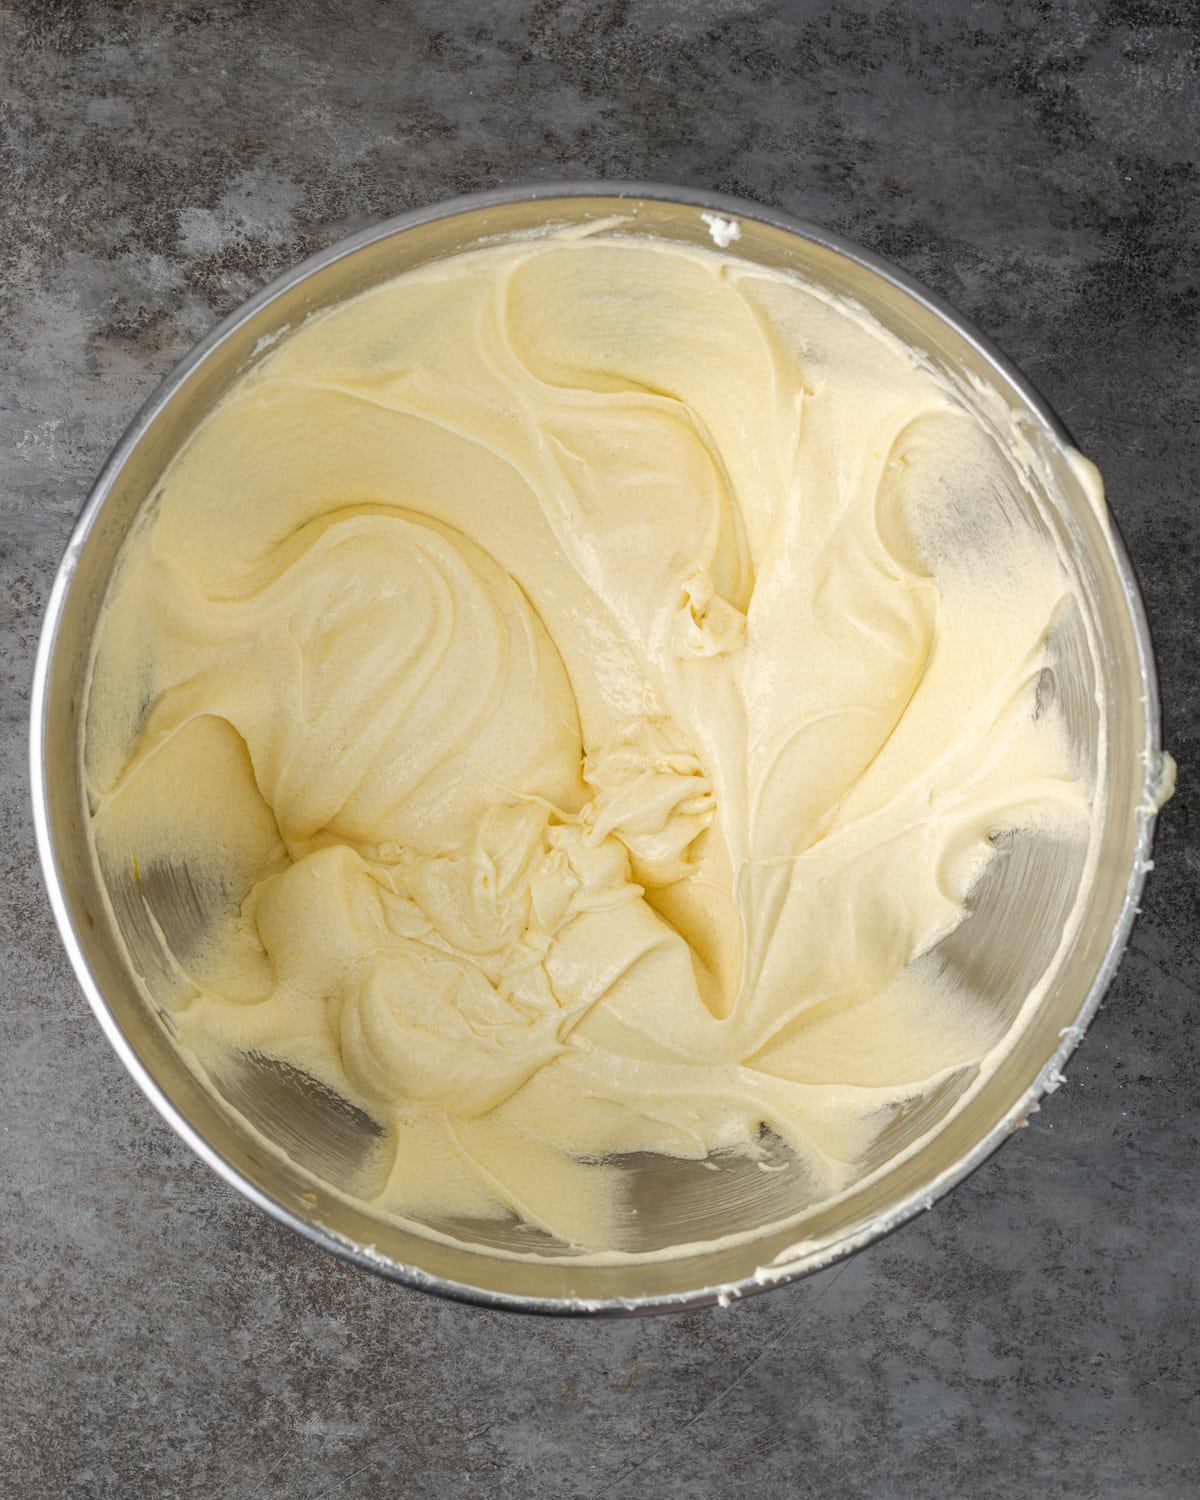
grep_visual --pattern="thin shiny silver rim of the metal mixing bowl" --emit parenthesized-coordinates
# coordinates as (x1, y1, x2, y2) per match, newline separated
(30, 180, 1163, 1316)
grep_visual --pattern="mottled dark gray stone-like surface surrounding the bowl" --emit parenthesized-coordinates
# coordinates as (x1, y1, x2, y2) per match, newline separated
(0, 0, 1200, 1500)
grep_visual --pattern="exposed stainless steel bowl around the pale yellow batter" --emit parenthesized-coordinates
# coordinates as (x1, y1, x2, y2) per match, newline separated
(32, 185, 1164, 1313)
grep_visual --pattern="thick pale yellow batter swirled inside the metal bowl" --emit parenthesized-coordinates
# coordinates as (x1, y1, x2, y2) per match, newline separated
(87, 234, 1094, 1250)
